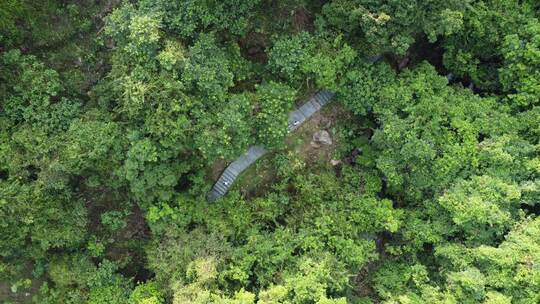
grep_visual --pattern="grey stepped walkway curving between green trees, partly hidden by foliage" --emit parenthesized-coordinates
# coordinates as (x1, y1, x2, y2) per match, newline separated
(206, 91, 334, 202)
